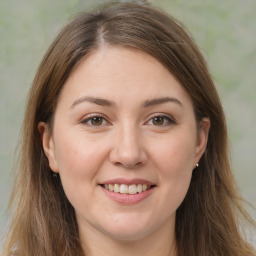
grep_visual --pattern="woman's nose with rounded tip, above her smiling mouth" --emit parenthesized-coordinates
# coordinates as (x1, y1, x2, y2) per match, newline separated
(110, 125, 148, 169)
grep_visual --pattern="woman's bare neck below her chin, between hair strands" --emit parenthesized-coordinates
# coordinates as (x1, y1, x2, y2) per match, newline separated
(80, 218, 177, 256)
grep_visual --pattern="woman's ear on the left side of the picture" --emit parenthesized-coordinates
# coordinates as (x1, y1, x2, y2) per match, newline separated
(38, 122, 59, 173)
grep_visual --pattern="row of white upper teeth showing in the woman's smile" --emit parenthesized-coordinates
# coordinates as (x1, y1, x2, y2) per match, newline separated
(104, 184, 151, 195)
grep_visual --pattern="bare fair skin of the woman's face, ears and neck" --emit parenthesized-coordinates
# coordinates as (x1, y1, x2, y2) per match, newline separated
(39, 46, 210, 256)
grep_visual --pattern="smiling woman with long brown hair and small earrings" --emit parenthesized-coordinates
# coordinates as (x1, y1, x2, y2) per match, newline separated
(3, 3, 255, 256)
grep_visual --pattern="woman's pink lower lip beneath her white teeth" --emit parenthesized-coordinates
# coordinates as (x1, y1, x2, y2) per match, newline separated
(101, 187, 155, 204)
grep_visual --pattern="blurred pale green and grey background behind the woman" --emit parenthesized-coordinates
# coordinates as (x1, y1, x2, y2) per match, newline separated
(0, 0, 256, 240)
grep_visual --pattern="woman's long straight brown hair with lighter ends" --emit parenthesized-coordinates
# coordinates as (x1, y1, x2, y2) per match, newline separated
(3, 3, 255, 256)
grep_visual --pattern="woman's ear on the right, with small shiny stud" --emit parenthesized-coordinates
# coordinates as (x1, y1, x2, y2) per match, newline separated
(194, 117, 211, 167)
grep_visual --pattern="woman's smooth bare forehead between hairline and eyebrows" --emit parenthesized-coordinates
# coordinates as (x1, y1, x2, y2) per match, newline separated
(56, 46, 192, 109)
